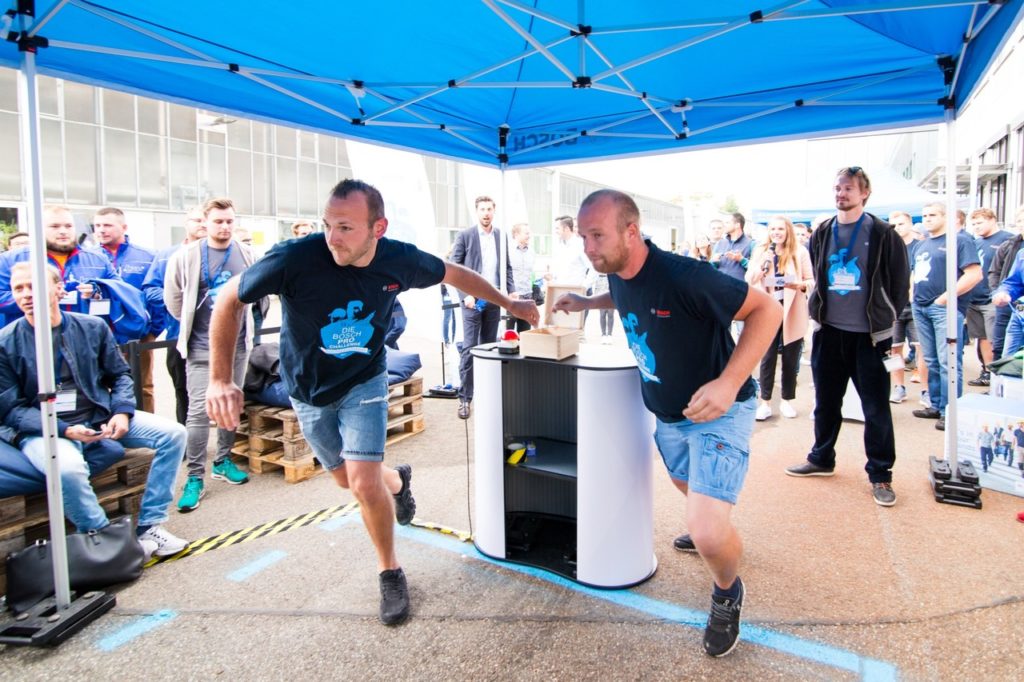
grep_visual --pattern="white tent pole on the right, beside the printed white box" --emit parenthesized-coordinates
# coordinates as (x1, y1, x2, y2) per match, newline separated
(944, 106, 961, 464)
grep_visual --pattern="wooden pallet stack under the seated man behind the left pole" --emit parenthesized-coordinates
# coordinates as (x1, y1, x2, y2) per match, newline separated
(0, 449, 153, 593)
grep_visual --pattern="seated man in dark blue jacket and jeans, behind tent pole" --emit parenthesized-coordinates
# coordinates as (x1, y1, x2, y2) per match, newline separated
(0, 262, 188, 556)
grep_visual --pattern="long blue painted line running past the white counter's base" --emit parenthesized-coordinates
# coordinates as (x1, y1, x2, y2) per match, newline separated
(398, 526, 899, 682)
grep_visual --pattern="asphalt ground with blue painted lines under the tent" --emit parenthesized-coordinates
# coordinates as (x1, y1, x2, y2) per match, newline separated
(0, 316, 1024, 680)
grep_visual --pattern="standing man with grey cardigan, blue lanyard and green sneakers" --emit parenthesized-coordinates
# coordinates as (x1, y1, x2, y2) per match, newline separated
(164, 199, 256, 512)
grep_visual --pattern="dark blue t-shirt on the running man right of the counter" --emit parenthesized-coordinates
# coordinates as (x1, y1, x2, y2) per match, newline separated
(608, 242, 754, 422)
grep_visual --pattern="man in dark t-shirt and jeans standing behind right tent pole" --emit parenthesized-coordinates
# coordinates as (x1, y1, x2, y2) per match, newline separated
(910, 202, 981, 431)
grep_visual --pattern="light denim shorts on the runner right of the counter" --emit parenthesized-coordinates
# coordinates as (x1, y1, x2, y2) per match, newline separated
(654, 397, 757, 505)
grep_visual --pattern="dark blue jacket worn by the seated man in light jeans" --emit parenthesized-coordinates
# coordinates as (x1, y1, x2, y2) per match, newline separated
(0, 312, 135, 436)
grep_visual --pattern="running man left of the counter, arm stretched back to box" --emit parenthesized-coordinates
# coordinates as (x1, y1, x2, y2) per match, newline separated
(199, 180, 540, 625)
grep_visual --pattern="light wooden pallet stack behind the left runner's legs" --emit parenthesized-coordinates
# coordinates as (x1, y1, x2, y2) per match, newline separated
(231, 377, 425, 483)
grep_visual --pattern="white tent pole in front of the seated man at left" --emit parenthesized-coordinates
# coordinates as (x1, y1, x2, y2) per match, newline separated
(17, 21, 71, 610)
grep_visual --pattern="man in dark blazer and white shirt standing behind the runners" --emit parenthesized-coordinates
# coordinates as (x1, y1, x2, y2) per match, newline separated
(452, 191, 515, 419)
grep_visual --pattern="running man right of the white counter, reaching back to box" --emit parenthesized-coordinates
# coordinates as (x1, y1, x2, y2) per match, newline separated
(554, 189, 782, 656)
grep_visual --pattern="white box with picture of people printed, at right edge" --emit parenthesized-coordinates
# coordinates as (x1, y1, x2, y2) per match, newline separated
(956, 393, 1024, 497)
